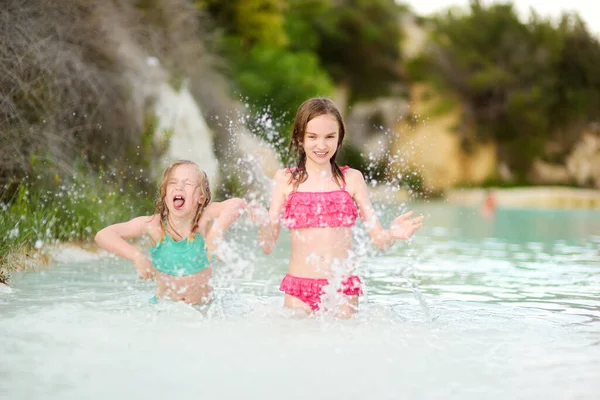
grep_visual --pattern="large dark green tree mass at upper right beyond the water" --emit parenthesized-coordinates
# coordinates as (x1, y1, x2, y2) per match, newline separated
(406, 1, 600, 179)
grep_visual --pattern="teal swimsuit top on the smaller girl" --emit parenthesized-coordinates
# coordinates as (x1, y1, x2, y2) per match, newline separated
(150, 233, 210, 276)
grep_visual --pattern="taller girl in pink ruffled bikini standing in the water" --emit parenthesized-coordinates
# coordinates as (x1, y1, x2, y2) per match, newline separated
(259, 98, 423, 317)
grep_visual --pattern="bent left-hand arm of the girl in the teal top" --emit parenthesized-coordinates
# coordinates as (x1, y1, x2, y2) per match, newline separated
(95, 216, 155, 279)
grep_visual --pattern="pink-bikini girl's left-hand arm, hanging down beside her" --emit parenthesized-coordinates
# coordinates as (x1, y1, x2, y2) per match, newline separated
(258, 169, 288, 254)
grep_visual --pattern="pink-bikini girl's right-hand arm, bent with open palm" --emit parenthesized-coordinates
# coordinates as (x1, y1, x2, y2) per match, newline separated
(351, 170, 425, 250)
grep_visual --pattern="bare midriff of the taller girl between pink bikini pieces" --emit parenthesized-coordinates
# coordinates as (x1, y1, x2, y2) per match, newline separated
(288, 227, 352, 278)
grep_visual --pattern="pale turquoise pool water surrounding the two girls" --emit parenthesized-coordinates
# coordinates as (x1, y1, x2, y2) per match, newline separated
(0, 202, 600, 399)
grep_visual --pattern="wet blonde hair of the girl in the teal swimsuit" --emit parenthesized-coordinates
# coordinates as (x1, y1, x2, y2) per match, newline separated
(155, 160, 211, 242)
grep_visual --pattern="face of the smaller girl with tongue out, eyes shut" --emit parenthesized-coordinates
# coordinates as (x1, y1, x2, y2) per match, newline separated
(164, 164, 203, 216)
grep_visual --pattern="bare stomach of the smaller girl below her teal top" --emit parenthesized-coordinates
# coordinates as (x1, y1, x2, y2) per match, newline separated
(156, 267, 212, 304)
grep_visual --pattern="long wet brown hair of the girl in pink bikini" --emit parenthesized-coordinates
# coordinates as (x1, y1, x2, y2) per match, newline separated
(289, 97, 346, 190)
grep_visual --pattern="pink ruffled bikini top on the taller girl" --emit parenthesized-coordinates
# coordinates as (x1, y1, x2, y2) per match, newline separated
(283, 166, 358, 229)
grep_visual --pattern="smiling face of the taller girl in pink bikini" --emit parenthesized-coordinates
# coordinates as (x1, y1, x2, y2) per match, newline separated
(302, 114, 339, 165)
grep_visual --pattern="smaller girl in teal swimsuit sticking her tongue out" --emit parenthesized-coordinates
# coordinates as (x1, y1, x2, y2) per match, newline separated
(96, 160, 260, 304)
